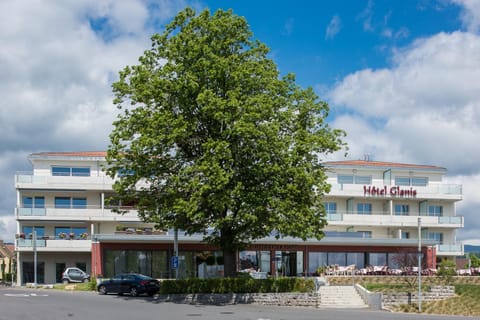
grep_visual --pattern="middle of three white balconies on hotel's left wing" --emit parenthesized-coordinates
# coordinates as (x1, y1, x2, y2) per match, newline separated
(16, 205, 139, 221)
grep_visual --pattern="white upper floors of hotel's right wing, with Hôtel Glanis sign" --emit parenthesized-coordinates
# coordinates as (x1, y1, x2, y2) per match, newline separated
(324, 160, 464, 257)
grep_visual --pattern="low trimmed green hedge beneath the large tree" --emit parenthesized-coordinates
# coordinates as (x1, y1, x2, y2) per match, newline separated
(160, 277, 315, 294)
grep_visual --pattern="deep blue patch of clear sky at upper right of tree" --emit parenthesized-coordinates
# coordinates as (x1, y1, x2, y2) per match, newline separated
(202, 0, 462, 94)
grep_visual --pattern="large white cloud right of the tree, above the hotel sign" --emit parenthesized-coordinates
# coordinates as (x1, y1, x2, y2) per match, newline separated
(329, 32, 480, 238)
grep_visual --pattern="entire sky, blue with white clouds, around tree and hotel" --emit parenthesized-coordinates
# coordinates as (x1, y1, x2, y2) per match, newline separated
(0, 0, 480, 244)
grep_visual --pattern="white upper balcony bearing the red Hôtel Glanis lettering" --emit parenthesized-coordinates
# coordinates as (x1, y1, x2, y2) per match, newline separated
(328, 183, 462, 201)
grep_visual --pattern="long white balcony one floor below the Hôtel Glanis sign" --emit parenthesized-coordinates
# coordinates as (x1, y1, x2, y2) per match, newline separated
(327, 212, 463, 228)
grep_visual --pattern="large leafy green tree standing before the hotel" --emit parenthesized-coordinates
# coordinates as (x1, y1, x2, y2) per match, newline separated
(107, 8, 344, 276)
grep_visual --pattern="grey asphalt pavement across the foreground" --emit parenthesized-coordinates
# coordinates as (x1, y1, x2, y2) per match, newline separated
(0, 287, 474, 320)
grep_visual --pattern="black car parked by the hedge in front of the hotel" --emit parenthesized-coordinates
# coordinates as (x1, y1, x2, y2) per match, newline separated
(97, 273, 160, 297)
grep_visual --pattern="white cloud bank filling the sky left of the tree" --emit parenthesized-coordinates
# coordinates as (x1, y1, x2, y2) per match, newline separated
(0, 0, 198, 240)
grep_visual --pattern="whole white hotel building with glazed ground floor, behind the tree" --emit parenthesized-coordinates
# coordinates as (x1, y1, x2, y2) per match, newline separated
(15, 152, 464, 285)
